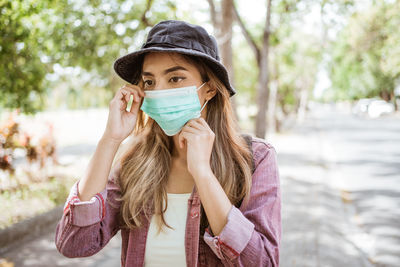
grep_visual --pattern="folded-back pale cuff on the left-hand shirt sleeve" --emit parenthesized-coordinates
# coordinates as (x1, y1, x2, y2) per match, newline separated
(64, 180, 107, 227)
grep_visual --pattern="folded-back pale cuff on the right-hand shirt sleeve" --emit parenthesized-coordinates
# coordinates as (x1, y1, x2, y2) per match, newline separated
(204, 205, 254, 260)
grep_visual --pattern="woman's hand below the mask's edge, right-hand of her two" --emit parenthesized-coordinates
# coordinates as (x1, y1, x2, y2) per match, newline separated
(179, 117, 215, 178)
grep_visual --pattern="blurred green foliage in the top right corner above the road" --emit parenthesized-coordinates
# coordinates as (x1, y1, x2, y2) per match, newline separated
(330, 1, 400, 100)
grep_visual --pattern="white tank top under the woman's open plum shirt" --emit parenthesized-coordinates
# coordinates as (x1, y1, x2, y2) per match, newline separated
(144, 193, 191, 267)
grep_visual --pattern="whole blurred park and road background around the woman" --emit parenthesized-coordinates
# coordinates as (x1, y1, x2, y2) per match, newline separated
(0, 0, 400, 267)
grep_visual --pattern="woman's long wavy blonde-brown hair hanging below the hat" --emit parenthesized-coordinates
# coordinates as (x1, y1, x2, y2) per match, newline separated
(114, 55, 252, 236)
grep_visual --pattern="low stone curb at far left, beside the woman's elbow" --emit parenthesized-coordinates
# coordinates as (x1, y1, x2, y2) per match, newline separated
(0, 204, 64, 255)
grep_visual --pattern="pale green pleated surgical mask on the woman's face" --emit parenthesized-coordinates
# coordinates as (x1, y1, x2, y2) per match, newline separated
(140, 83, 208, 136)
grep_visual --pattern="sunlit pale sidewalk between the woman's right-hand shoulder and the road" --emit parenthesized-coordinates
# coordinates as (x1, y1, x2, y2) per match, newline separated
(267, 113, 374, 267)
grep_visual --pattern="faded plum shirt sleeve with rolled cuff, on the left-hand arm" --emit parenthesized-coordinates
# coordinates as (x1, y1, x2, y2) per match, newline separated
(55, 163, 121, 258)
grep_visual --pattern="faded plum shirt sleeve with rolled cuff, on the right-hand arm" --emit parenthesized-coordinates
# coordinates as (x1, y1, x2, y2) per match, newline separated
(204, 139, 281, 266)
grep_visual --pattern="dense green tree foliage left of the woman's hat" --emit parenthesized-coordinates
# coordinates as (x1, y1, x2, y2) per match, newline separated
(0, 0, 176, 113)
